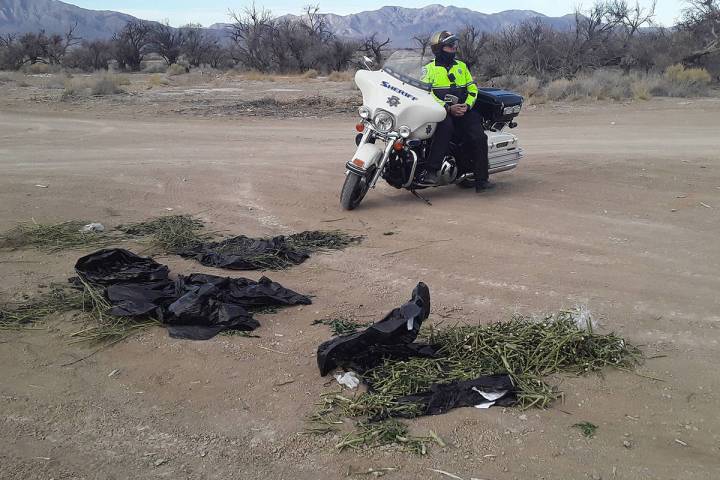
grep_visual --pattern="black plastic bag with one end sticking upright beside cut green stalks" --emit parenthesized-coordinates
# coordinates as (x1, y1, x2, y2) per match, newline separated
(317, 282, 435, 376)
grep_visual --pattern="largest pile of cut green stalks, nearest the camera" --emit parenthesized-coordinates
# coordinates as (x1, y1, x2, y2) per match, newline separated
(310, 310, 642, 448)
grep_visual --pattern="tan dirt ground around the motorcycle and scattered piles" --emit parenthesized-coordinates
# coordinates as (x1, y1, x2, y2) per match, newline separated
(0, 76, 720, 480)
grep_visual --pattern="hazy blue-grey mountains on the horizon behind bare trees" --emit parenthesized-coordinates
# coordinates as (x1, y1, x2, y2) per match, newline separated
(0, 0, 574, 47)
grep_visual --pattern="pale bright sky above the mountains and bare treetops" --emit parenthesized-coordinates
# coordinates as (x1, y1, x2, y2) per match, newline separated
(65, 0, 684, 26)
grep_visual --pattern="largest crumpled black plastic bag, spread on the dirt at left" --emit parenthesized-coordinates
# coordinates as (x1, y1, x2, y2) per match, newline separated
(75, 249, 312, 340)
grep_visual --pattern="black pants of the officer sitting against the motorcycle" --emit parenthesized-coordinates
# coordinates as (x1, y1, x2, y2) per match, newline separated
(425, 110, 489, 180)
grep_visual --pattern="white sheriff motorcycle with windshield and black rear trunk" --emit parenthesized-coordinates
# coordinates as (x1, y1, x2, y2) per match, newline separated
(340, 50, 523, 210)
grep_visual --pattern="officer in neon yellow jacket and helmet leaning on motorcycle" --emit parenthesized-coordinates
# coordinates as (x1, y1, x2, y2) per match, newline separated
(421, 31, 494, 190)
